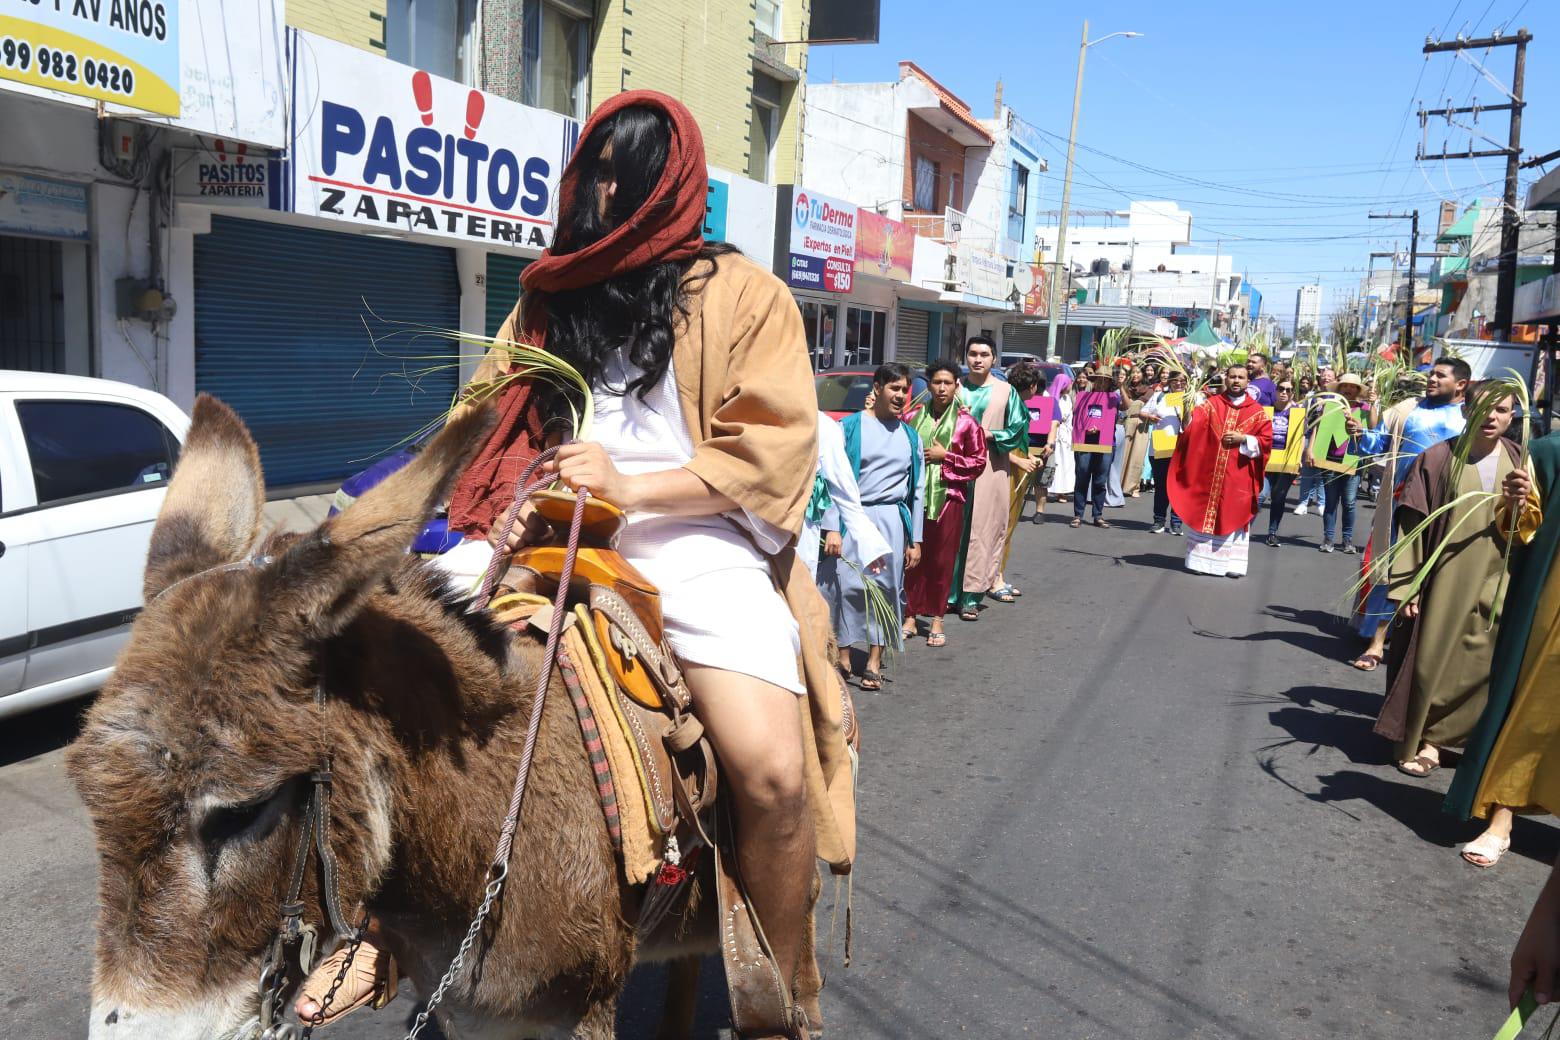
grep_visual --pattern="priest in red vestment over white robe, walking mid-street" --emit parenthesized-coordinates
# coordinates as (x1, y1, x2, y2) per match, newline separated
(1170, 365, 1273, 578)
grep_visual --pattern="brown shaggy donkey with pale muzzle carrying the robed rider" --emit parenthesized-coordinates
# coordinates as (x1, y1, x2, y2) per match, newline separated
(66, 396, 776, 1040)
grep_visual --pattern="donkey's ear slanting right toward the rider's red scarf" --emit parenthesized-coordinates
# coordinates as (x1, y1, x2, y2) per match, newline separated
(264, 404, 498, 639)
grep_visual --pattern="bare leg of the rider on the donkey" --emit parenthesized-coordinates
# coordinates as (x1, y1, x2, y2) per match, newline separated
(683, 664, 816, 997)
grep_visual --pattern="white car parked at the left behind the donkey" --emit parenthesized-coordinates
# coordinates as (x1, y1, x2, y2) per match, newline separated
(0, 371, 190, 719)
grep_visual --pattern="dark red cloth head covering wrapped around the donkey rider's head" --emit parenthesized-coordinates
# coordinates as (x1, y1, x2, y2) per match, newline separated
(449, 90, 710, 536)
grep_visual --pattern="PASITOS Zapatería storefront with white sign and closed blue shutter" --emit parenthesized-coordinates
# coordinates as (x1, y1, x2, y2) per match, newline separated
(181, 31, 579, 488)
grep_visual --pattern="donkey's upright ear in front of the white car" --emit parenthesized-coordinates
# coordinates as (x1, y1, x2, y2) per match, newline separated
(140, 394, 265, 600)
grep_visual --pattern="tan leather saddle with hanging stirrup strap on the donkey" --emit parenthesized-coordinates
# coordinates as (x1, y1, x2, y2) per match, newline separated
(501, 491, 810, 1040)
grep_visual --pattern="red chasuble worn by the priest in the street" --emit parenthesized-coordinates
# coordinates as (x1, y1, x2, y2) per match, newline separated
(1170, 393, 1266, 538)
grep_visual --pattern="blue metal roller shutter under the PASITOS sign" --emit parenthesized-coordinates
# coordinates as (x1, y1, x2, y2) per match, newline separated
(195, 217, 460, 486)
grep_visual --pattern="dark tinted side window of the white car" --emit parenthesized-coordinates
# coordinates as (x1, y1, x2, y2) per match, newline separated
(16, 401, 179, 505)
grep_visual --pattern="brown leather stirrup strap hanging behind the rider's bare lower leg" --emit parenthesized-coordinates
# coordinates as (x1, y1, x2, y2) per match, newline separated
(714, 806, 807, 1040)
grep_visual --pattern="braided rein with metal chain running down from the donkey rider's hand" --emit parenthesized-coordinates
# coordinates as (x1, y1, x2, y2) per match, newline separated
(406, 447, 590, 1040)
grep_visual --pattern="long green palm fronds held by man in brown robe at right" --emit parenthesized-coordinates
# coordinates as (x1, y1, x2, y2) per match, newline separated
(1348, 370, 1532, 628)
